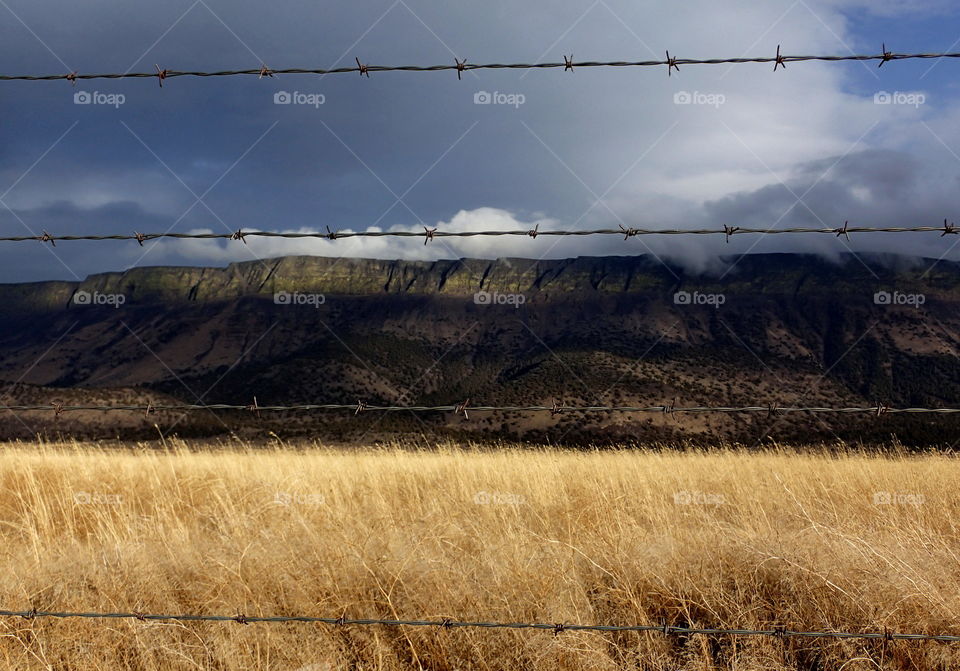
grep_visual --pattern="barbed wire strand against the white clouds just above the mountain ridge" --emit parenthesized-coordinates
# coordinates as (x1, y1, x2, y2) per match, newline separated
(0, 219, 960, 246)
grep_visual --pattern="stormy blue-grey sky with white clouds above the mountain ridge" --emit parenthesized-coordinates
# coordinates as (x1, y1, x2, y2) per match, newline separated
(0, 0, 960, 282)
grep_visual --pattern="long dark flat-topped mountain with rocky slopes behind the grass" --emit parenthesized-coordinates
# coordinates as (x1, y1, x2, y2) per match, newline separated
(0, 255, 960, 442)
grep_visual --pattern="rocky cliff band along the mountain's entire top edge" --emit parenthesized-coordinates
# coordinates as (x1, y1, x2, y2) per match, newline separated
(0, 254, 960, 312)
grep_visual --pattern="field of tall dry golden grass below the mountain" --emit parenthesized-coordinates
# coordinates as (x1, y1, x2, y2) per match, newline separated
(0, 443, 960, 671)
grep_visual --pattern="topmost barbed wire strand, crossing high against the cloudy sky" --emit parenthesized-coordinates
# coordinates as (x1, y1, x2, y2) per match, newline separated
(0, 44, 960, 87)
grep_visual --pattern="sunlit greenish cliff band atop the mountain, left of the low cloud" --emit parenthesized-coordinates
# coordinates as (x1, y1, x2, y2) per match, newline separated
(0, 256, 673, 313)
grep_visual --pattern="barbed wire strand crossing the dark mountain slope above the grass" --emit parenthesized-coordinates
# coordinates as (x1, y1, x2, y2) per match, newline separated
(9, 397, 960, 418)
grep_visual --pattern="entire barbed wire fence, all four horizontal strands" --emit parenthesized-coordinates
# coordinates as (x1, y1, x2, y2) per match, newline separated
(0, 39, 960, 660)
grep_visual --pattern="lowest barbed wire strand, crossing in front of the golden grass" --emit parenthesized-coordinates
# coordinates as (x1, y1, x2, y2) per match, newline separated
(0, 609, 960, 643)
